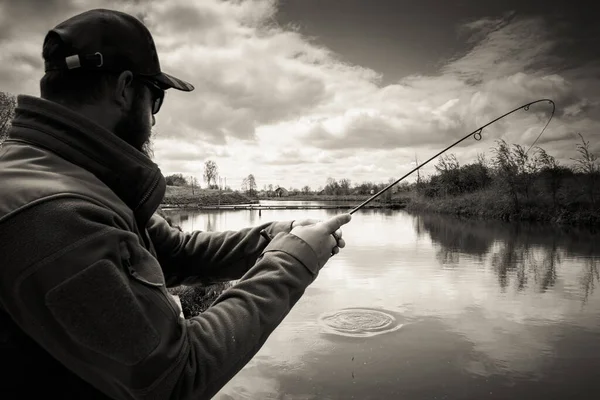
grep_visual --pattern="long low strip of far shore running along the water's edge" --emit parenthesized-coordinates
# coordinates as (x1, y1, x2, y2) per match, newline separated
(161, 186, 600, 227)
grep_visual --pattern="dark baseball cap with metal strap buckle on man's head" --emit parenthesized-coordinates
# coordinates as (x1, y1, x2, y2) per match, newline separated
(44, 9, 194, 92)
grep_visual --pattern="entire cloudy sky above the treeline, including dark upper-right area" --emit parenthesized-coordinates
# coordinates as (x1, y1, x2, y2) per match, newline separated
(0, 0, 600, 189)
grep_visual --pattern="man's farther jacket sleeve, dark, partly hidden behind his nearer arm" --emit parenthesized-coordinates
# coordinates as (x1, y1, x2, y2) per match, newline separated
(148, 214, 293, 287)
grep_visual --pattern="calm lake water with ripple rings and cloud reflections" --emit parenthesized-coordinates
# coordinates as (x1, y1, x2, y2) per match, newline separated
(163, 205, 600, 400)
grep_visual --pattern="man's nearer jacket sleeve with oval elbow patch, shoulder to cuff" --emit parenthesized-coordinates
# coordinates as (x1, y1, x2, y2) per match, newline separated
(0, 200, 318, 400)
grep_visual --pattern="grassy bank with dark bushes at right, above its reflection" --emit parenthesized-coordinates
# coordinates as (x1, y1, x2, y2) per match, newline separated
(406, 189, 600, 227)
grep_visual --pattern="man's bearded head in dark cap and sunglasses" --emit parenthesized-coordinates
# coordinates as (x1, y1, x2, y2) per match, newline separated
(40, 9, 194, 154)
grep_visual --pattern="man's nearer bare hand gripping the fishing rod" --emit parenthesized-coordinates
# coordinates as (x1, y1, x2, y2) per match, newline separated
(290, 214, 352, 268)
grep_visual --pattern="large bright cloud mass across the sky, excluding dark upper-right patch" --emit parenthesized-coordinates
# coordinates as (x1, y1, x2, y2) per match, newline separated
(0, 0, 600, 187)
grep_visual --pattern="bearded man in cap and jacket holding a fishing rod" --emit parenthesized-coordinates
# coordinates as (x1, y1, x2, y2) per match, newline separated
(0, 10, 350, 399)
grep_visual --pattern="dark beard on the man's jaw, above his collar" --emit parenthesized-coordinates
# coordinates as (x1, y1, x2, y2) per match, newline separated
(114, 98, 154, 158)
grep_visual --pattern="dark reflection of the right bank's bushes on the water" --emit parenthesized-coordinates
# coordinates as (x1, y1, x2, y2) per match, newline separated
(413, 215, 600, 303)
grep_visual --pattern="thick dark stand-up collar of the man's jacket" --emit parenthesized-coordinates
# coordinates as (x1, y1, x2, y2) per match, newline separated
(10, 95, 166, 225)
